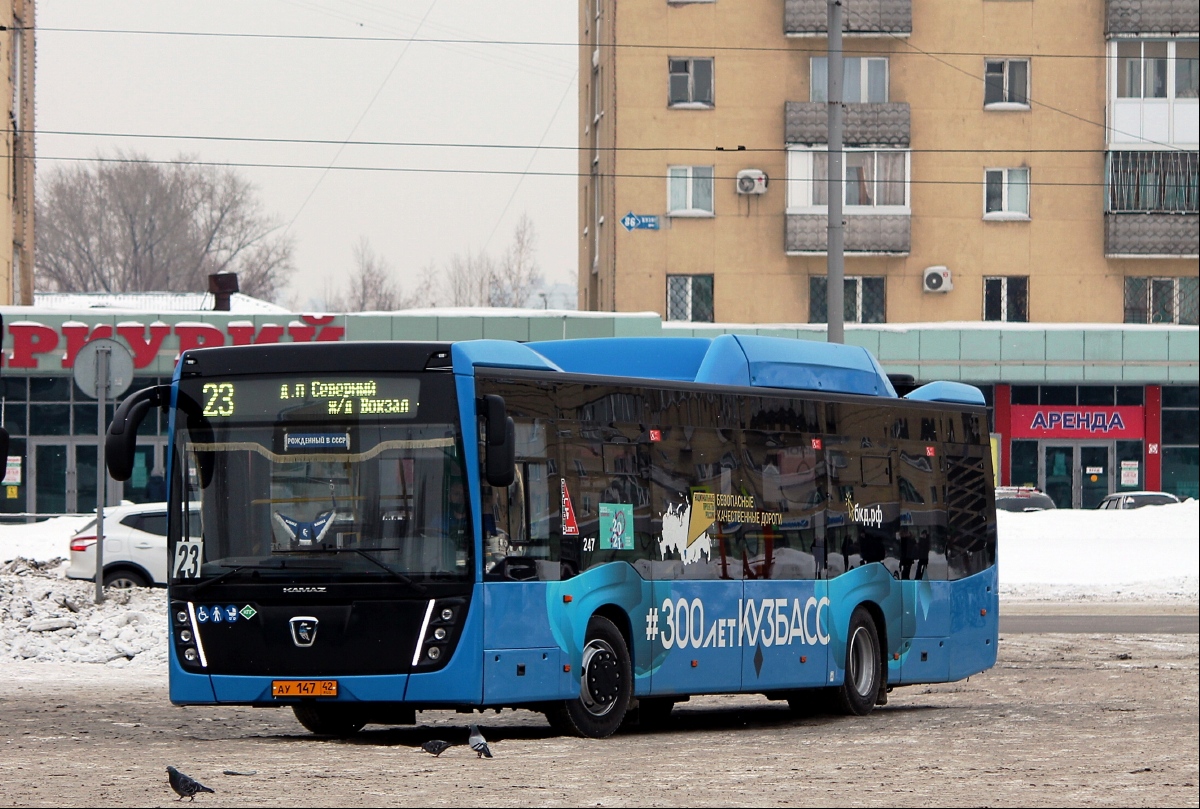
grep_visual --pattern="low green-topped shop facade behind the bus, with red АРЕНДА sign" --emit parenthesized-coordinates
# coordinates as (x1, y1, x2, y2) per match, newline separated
(0, 306, 1200, 515)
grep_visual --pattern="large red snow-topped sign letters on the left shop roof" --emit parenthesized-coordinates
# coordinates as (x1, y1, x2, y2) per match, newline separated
(4, 314, 346, 370)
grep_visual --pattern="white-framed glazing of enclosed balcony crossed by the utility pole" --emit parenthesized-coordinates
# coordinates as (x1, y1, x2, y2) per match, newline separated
(787, 149, 908, 214)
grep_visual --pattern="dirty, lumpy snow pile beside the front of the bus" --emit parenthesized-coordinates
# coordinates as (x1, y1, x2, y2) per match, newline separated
(0, 558, 167, 669)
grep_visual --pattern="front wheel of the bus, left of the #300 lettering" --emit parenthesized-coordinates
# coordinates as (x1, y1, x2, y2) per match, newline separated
(546, 616, 634, 738)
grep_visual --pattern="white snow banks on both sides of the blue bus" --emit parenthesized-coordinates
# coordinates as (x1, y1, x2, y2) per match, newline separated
(0, 501, 1200, 671)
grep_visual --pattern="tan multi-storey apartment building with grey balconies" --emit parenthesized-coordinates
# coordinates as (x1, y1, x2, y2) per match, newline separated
(578, 0, 1200, 324)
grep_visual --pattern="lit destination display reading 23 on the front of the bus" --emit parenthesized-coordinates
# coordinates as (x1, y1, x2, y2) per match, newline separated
(200, 377, 420, 419)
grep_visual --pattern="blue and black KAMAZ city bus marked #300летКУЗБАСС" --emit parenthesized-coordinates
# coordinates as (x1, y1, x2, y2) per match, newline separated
(106, 335, 998, 738)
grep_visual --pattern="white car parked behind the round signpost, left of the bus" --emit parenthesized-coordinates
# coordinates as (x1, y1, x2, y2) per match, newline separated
(67, 503, 198, 589)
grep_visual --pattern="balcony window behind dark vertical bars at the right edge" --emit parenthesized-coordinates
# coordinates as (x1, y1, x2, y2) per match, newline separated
(1108, 151, 1200, 214)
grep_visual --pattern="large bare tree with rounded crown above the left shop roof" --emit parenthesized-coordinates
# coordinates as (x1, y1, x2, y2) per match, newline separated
(36, 151, 293, 300)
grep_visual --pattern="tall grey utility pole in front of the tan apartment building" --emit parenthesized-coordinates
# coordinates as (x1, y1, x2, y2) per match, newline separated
(826, 0, 846, 343)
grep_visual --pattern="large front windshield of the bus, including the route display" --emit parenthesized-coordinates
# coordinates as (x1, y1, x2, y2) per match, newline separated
(172, 374, 473, 583)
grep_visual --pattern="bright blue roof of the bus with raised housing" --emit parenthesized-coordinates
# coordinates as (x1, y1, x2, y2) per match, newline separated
(451, 335, 984, 405)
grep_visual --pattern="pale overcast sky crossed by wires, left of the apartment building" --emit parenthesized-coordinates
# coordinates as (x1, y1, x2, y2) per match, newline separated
(37, 0, 577, 307)
